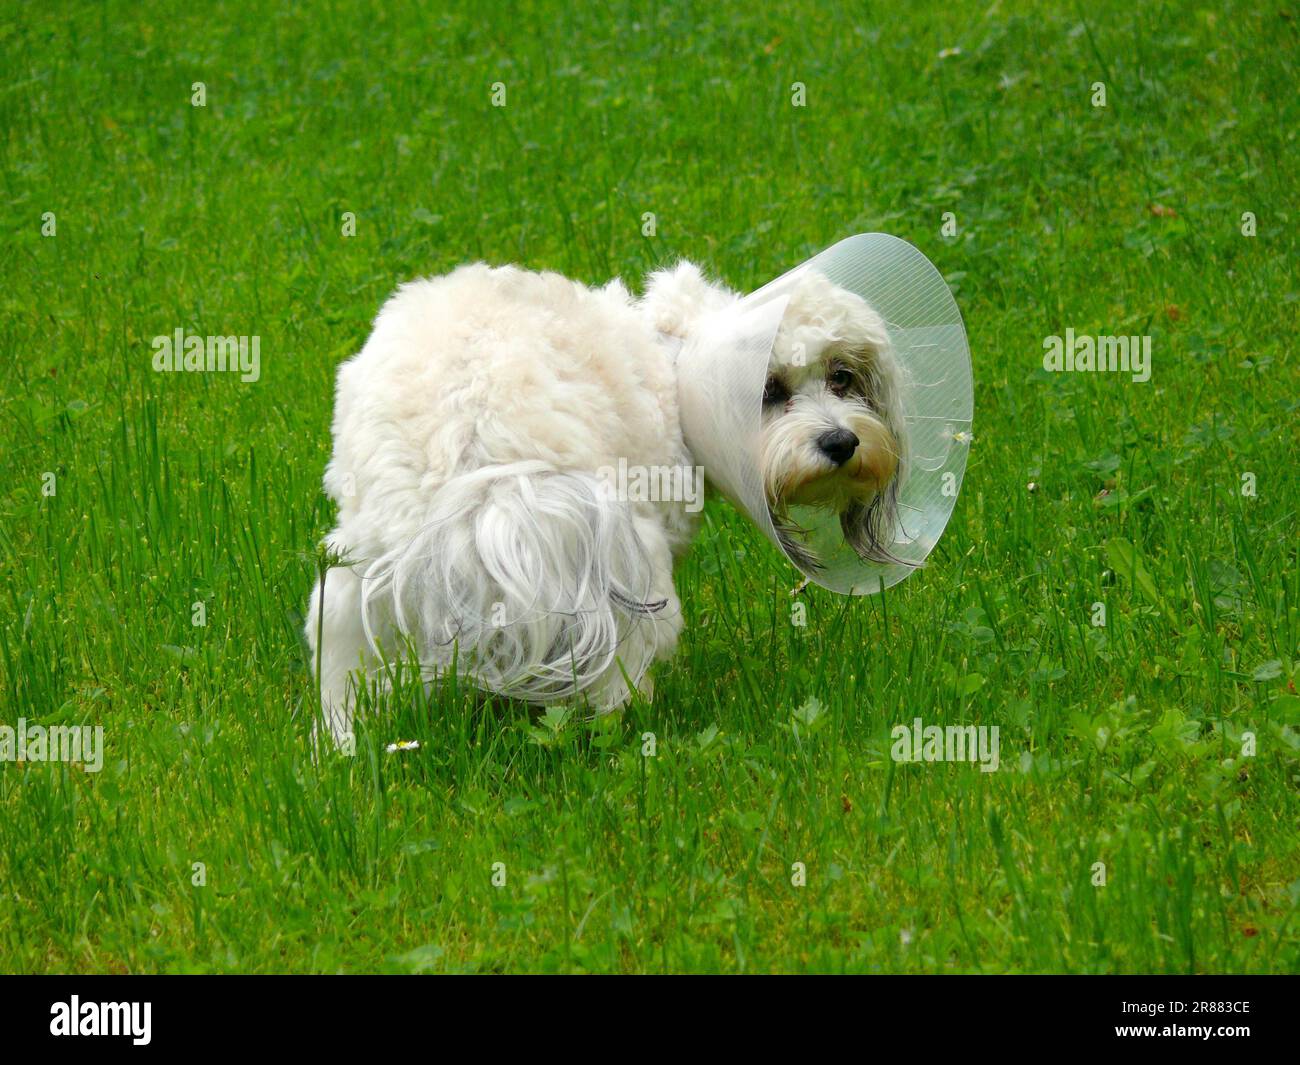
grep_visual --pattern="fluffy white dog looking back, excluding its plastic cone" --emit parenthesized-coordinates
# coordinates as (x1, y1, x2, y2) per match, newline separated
(306, 263, 905, 743)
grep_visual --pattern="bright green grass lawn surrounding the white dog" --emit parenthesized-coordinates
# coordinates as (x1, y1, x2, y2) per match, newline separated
(0, 0, 1300, 973)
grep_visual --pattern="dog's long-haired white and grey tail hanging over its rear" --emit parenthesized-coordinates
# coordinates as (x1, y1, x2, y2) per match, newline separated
(361, 462, 681, 709)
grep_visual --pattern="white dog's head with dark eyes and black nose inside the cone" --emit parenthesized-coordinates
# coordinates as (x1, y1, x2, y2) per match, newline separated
(759, 273, 906, 568)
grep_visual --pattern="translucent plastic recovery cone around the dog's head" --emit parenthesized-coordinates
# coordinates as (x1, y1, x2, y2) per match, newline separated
(677, 233, 974, 596)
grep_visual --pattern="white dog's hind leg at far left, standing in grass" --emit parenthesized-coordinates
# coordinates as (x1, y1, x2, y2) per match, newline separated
(307, 566, 372, 750)
